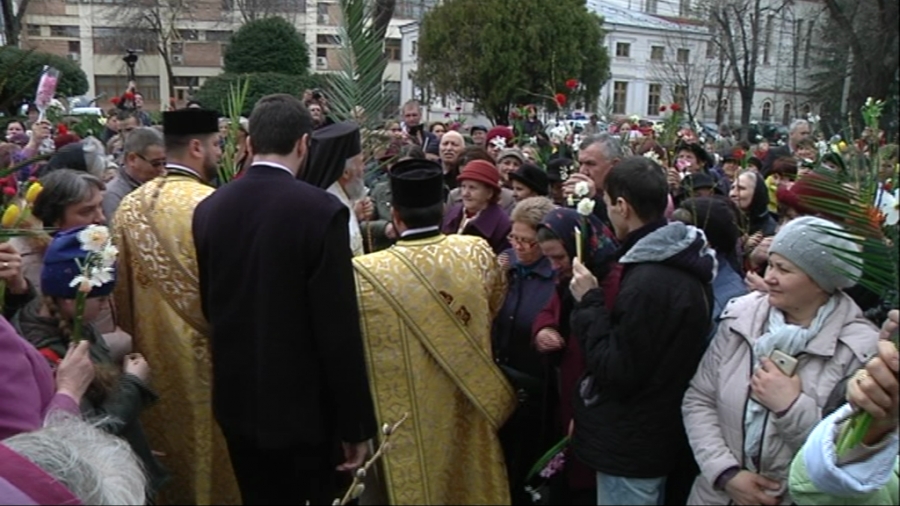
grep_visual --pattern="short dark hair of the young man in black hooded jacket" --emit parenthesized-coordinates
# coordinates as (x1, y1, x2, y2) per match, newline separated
(604, 156, 669, 222)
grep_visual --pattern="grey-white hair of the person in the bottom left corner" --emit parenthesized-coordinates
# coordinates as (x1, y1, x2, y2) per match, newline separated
(3, 411, 147, 505)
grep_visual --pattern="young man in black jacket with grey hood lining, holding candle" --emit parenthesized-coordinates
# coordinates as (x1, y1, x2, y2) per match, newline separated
(571, 157, 715, 505)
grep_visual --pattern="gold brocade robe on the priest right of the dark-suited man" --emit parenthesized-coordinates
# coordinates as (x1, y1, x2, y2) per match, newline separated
(353, 235, 517, 505)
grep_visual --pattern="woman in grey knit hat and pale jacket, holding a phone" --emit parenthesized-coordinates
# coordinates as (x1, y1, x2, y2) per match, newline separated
(682, 216, 878, 504)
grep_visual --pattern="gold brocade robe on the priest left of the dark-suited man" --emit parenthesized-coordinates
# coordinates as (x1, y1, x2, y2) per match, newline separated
(114, 174, 241, 504)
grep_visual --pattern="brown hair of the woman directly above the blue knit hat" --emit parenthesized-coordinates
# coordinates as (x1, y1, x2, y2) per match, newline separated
(32, 169, 106, 227)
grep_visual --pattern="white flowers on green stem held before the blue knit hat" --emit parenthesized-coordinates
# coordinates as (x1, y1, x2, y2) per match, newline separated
(69, 225, 119, 343)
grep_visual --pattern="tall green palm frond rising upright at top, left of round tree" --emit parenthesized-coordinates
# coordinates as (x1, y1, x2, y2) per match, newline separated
(327, 0, 390, 154)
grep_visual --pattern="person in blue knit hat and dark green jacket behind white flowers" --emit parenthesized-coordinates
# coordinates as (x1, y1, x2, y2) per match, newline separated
(13, 225, 167, 497)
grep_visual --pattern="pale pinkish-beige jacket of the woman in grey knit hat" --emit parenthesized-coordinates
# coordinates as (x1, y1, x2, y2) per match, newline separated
(681, 292, 878, 504)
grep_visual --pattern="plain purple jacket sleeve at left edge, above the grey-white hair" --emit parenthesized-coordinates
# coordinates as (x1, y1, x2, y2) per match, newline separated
(0, 316, 81, 440)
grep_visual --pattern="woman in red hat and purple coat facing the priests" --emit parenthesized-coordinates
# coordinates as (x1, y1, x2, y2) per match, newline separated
(441, 160, 511, 254)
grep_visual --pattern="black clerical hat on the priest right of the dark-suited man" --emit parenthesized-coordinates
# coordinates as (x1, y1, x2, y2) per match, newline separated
(391, 160, 444, 209)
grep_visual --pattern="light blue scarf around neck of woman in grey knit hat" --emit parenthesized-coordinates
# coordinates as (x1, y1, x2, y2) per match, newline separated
(744, 297, 837, 472)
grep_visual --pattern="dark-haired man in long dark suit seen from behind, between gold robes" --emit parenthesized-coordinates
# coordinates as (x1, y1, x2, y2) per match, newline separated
(193, 95, 376, 504)
